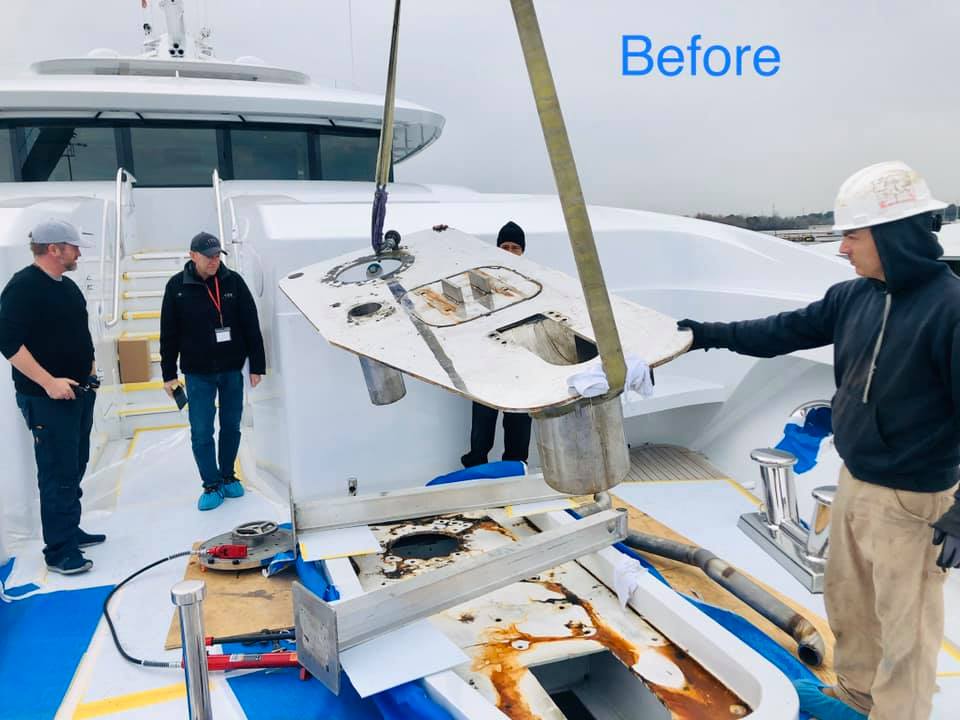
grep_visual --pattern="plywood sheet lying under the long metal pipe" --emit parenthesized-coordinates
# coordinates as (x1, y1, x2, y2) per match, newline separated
(613, 495, 836, 685)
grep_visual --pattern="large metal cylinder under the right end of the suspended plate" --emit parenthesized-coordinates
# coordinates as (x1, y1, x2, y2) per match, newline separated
(533, 397, 630, 495)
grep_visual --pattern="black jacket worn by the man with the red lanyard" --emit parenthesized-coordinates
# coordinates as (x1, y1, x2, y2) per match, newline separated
(160, 260, 267, 381)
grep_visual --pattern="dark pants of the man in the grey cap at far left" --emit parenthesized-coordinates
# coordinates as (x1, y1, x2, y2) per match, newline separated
(17, 391, 96, 563)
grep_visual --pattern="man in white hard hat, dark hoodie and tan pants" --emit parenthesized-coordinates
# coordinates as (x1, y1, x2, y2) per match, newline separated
(677, 162, 960, 720)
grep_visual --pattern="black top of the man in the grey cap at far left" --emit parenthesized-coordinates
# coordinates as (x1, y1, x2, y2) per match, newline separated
(0, 265, 93, 395)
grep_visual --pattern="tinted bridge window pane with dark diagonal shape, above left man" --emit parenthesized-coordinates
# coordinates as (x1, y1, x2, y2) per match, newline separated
(15, 125, 117, 182)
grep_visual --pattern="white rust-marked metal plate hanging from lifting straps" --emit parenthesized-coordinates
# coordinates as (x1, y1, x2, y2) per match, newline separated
(280, 228, 690, 412)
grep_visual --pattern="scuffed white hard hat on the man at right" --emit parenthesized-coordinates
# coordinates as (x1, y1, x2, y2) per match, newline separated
(833, 160, 947, 231)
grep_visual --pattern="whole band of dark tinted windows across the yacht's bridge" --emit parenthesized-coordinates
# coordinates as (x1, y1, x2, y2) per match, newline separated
(0, 119, 382, 187)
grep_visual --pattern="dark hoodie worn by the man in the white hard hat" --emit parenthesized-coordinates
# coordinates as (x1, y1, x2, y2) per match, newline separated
(701, 214, 960, 534)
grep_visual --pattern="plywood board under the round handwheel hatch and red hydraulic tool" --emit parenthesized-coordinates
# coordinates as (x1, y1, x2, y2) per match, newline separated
(163, 547, 296, 650)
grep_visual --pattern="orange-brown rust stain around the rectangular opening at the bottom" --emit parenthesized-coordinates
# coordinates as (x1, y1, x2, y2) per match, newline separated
(472, 580, 749, 720)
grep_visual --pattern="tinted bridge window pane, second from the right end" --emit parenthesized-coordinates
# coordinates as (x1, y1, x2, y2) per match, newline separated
(230, 130, 310, 180)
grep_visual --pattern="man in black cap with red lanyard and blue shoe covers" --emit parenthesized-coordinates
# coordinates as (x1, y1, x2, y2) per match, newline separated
(160, 232, 267, 510)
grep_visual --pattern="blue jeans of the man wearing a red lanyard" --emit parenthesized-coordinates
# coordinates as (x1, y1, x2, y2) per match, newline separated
(185, 370, 243, 488)
